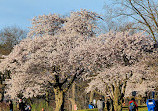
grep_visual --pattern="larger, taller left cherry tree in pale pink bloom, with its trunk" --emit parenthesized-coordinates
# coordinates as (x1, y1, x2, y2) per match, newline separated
(0, 10, 98, 111)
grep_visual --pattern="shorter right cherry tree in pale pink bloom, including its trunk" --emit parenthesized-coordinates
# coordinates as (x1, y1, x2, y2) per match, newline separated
(72, 32, 157, 111)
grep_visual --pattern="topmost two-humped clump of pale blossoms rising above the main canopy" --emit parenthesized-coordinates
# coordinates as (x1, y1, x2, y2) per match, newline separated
(28, 9, 101, 37)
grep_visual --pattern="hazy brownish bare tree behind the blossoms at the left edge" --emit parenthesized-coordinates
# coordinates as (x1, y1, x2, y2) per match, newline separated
(0, 26, 27, 55)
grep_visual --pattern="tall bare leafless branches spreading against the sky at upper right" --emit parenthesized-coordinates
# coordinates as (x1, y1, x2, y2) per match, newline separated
(106, 0, 158, 42)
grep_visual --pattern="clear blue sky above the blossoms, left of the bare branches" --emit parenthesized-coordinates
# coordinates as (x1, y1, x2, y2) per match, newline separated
(0, 0, 105, 29)
